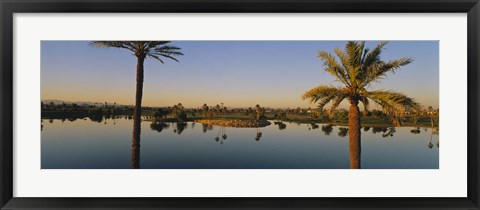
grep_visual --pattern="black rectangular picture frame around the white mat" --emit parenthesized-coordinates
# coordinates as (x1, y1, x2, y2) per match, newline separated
(0, 0, 480, 209)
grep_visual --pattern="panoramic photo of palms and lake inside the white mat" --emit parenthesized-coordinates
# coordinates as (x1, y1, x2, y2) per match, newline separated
(40, 40, 440, 170)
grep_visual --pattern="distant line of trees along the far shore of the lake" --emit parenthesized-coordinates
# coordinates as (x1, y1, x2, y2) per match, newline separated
(41, 102, 439, 127)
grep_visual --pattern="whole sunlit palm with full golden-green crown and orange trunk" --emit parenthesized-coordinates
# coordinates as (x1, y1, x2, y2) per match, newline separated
(302, 41, 420, 168)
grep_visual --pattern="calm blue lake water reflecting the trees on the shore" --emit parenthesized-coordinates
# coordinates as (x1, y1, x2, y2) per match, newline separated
(41, 119, 440, 169)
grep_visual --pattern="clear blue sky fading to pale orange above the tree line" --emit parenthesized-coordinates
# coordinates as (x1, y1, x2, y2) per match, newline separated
(41, 41, 439, 108)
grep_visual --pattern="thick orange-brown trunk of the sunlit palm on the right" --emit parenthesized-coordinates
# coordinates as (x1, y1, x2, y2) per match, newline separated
(348, 100, 361, 169)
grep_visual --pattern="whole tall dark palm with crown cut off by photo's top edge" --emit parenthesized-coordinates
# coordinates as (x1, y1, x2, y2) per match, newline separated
(91, 41, 183, 168)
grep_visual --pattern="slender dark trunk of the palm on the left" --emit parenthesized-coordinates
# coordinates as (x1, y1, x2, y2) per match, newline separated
(131, 56, 145, 169)
